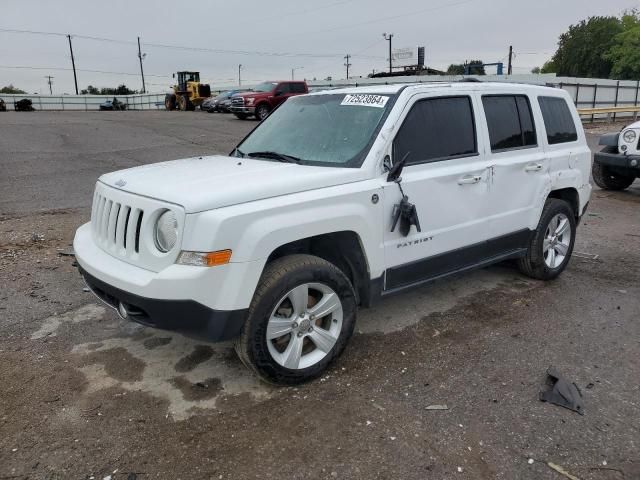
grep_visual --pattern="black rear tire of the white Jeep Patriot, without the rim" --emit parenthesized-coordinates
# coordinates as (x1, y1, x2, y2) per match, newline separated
(518, 198, 576, 280)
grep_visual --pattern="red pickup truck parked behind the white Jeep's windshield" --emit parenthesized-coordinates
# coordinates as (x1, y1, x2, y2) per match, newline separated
(231, 81, 309, 120)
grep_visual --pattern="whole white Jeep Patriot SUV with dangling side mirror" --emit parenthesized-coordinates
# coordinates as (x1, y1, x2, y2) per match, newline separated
(74, 83, 591, 384)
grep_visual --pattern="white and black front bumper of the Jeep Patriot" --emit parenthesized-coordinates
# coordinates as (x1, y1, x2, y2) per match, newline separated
(73, 224, 255, 341)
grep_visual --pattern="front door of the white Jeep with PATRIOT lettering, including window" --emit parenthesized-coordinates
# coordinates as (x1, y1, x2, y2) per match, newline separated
(383, 94, 491, 291)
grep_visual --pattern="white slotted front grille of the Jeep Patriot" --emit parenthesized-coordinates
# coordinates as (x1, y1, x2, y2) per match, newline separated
(91, 192, 144, 255)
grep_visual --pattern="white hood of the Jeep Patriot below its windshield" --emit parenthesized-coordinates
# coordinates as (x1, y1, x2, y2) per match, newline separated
(100, 155, 366, 213)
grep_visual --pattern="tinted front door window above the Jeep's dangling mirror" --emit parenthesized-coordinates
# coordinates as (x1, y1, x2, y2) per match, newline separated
(393, 97, 478, 165)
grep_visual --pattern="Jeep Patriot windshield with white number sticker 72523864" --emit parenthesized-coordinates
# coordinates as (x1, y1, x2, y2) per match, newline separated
(236, 94, 391, 167)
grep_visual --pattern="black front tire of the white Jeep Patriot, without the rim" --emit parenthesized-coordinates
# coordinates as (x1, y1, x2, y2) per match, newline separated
(235, 255, 357, 385)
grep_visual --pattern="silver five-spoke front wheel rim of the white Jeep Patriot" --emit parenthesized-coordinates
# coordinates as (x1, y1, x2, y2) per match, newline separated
(266, 283, 343, 370)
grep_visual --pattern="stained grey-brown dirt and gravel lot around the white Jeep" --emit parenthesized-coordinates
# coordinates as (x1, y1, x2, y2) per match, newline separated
(0, 112, 640, 480)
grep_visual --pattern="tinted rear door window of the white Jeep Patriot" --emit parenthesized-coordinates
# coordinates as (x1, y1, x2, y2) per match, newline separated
(482, 95, 537, 152)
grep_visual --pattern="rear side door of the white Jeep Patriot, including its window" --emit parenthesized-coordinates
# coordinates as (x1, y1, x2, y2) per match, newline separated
(480, 93, 550, 235)
